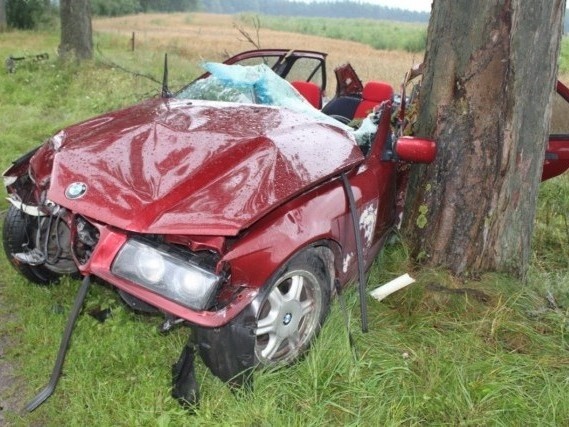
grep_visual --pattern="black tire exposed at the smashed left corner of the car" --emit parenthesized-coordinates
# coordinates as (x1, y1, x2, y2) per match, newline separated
(2, 205, 61, 285)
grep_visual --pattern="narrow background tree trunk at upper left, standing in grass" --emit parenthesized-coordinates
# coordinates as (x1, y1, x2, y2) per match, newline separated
(59, 0, 93, 60)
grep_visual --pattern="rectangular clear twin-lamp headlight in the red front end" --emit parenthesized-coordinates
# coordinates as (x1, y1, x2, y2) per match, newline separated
(111, 239, 221, 310)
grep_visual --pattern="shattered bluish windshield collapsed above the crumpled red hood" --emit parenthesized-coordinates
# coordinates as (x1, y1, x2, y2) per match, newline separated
(176, 62, 353, 131)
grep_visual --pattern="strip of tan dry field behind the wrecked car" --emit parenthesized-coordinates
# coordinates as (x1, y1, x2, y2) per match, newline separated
(93, 13, 423, 93)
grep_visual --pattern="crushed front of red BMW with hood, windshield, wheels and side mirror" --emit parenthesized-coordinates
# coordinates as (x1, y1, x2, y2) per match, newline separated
(3, 51, 436, 409)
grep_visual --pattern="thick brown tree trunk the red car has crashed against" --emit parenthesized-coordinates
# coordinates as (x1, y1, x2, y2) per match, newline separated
(404, 0, 566, 278)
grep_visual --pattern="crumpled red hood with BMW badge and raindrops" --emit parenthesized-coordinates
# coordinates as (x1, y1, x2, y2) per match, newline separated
(40, 99, 363, 235)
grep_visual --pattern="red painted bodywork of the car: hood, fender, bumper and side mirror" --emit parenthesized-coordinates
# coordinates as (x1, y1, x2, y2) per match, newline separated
(3, 50, 444, 327)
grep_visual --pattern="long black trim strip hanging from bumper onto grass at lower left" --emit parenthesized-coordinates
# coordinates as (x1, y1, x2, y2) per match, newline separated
(25, 276, 91, 412)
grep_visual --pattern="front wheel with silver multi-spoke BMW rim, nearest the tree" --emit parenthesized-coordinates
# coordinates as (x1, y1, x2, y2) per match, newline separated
(255, 249, 332, 366)
